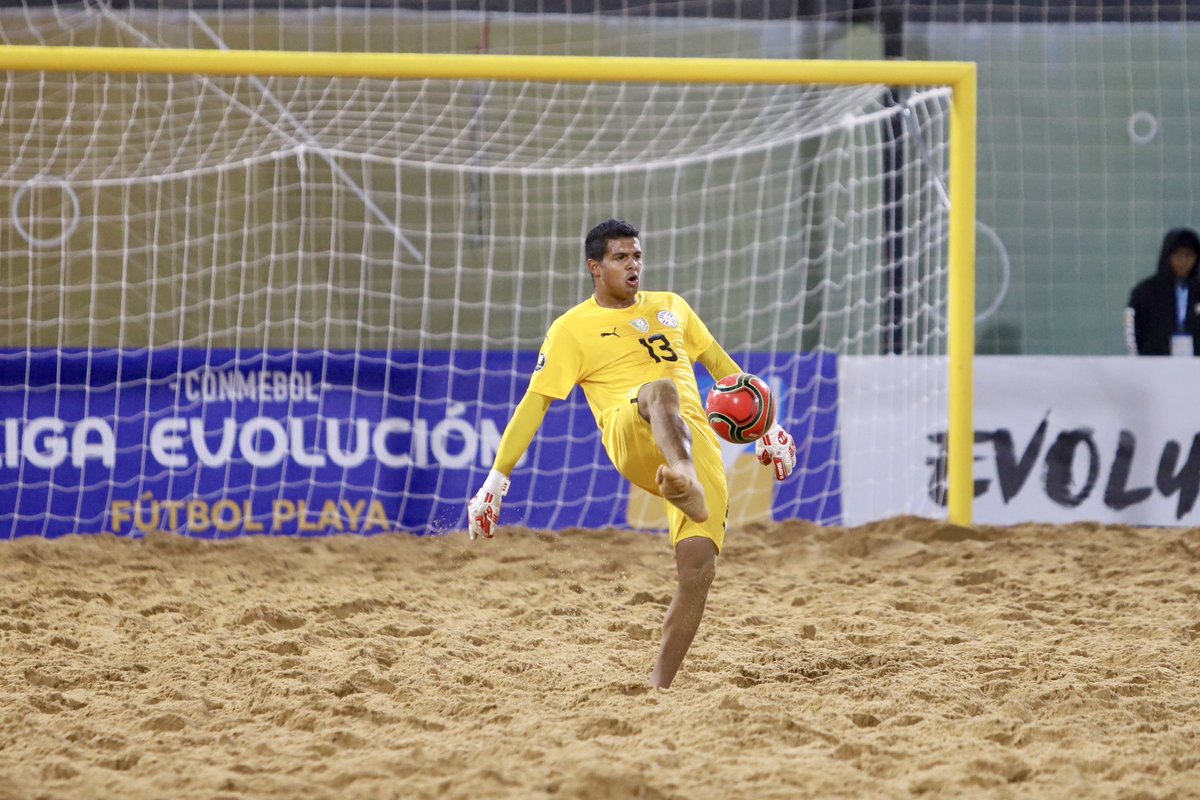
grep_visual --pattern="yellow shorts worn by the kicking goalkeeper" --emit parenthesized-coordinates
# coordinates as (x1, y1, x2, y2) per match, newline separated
(600, 390, 730, 552)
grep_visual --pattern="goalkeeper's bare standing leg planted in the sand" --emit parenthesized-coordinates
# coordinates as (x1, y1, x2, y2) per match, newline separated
(650, 536, 716, 688)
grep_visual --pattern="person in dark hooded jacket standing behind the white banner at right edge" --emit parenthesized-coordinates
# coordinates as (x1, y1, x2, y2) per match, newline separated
(1124, 228, 1200, 356)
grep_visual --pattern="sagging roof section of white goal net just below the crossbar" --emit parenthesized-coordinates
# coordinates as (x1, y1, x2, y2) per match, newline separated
(0, 73, 880, 176)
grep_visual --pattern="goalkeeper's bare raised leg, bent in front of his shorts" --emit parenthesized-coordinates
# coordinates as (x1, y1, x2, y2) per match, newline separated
(637, 378, 708, 522)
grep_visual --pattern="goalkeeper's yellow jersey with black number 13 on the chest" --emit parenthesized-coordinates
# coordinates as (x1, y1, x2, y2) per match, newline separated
(529, 291, 713, 427)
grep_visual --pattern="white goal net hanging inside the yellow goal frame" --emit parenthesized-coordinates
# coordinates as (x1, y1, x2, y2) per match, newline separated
(0, 18, 950, 537)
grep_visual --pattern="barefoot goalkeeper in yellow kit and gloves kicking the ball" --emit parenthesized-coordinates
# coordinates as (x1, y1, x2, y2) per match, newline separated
(467, 219, 796, 688)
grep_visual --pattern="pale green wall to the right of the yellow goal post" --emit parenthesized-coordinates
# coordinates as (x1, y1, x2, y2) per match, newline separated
(911, 25, 1200, 355)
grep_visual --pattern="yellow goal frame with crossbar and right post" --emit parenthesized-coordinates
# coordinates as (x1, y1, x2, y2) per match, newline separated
(0, 46, 977, 525)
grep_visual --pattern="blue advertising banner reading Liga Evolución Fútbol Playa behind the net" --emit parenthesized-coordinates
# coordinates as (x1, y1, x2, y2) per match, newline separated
(0, 349, 841, 539)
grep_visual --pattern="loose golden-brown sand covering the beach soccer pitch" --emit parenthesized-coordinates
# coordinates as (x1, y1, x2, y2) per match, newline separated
(0, 518, 1200, 800)
